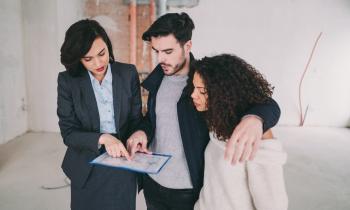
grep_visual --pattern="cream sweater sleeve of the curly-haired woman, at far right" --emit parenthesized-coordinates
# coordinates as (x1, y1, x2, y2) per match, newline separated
(247, 140, 288, 210)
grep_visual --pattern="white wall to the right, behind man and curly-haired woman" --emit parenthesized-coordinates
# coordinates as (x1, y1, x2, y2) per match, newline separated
(170, 0, 350, 127)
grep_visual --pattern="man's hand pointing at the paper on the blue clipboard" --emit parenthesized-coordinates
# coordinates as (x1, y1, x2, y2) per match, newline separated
(126, 131, 152, 157)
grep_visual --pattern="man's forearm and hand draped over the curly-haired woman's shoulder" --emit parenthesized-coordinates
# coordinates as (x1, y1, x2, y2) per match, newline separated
(225, 98, 281, 164)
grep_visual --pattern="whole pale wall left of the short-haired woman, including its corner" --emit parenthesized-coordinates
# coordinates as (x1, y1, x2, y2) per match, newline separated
(0, 0, 84, 144)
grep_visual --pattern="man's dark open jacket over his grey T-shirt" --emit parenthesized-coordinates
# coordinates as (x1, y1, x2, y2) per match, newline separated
(139, 54, 280, 196)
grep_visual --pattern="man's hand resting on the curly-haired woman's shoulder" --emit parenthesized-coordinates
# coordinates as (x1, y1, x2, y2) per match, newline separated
(225, 116, 263, 165)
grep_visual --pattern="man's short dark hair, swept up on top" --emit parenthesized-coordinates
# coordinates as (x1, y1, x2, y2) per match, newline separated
(142, 12, 194, 45)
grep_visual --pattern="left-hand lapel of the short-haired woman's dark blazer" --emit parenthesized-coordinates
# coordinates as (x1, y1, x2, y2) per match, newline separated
(80, 71, 100, 132)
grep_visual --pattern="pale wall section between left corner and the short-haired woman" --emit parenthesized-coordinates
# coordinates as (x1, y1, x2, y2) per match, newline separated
(22, 0, 82, 131)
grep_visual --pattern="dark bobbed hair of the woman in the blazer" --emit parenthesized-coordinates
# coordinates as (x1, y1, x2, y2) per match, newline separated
(61, 19, 114, 76)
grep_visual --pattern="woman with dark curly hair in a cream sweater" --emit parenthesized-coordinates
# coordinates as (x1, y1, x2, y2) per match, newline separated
(191, 54, 288, 210)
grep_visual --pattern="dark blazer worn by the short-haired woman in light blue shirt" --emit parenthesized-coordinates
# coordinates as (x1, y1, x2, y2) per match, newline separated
(57, 62, 142, 188)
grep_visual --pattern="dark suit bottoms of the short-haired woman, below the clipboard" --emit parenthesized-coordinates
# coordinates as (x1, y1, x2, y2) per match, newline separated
(71, 166, 136, 210)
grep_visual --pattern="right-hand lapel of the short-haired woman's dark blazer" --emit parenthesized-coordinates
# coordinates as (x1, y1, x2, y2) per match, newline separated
(111, 65, 122, 133)
